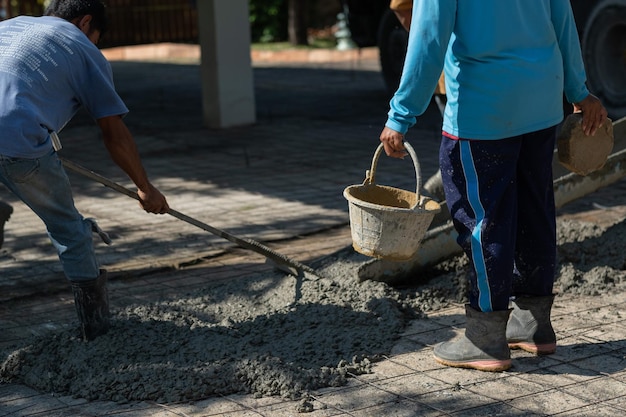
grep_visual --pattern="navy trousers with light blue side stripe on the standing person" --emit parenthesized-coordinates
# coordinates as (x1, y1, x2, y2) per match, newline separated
(439, 127, 556, 312)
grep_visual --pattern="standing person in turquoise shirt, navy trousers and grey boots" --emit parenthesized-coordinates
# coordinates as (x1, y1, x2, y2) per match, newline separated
(380, 0, 607, 371)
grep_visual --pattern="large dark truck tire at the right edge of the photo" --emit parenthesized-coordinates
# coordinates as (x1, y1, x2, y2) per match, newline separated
(582, 0, 626, 120)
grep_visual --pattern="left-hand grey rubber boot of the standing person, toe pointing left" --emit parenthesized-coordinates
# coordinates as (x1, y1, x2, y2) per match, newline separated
(433, 304, 511, 372)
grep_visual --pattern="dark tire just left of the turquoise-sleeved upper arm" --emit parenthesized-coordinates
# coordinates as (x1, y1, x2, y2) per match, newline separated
(377, 9, 409, 95)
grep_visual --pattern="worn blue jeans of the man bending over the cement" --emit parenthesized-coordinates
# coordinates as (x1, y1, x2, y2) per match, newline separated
(0, 151, 100, 281)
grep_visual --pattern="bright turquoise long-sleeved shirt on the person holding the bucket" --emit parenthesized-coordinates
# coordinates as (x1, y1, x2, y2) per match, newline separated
(386, 0, 589, 139)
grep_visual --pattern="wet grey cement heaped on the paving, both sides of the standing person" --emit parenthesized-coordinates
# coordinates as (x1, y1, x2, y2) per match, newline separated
(0, 216, 626, 402)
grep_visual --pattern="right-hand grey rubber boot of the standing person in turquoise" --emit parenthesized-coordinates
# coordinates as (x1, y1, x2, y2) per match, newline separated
(506, 295, 556, 355)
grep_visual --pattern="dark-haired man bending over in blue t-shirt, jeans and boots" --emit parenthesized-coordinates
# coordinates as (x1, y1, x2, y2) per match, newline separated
(0, 0, 169, 340)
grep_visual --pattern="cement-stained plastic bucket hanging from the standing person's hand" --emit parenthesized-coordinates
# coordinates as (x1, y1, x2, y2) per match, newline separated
(343, 142, 441, 261)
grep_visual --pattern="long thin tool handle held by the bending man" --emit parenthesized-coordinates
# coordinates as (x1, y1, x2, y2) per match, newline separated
(60, 158, 319, 278)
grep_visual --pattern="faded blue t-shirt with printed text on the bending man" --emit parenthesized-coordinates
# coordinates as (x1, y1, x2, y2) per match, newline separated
(0, 16, 128, 158)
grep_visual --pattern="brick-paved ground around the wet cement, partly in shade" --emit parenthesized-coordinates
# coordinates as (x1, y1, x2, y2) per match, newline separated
(0, 44, 626, 417)
